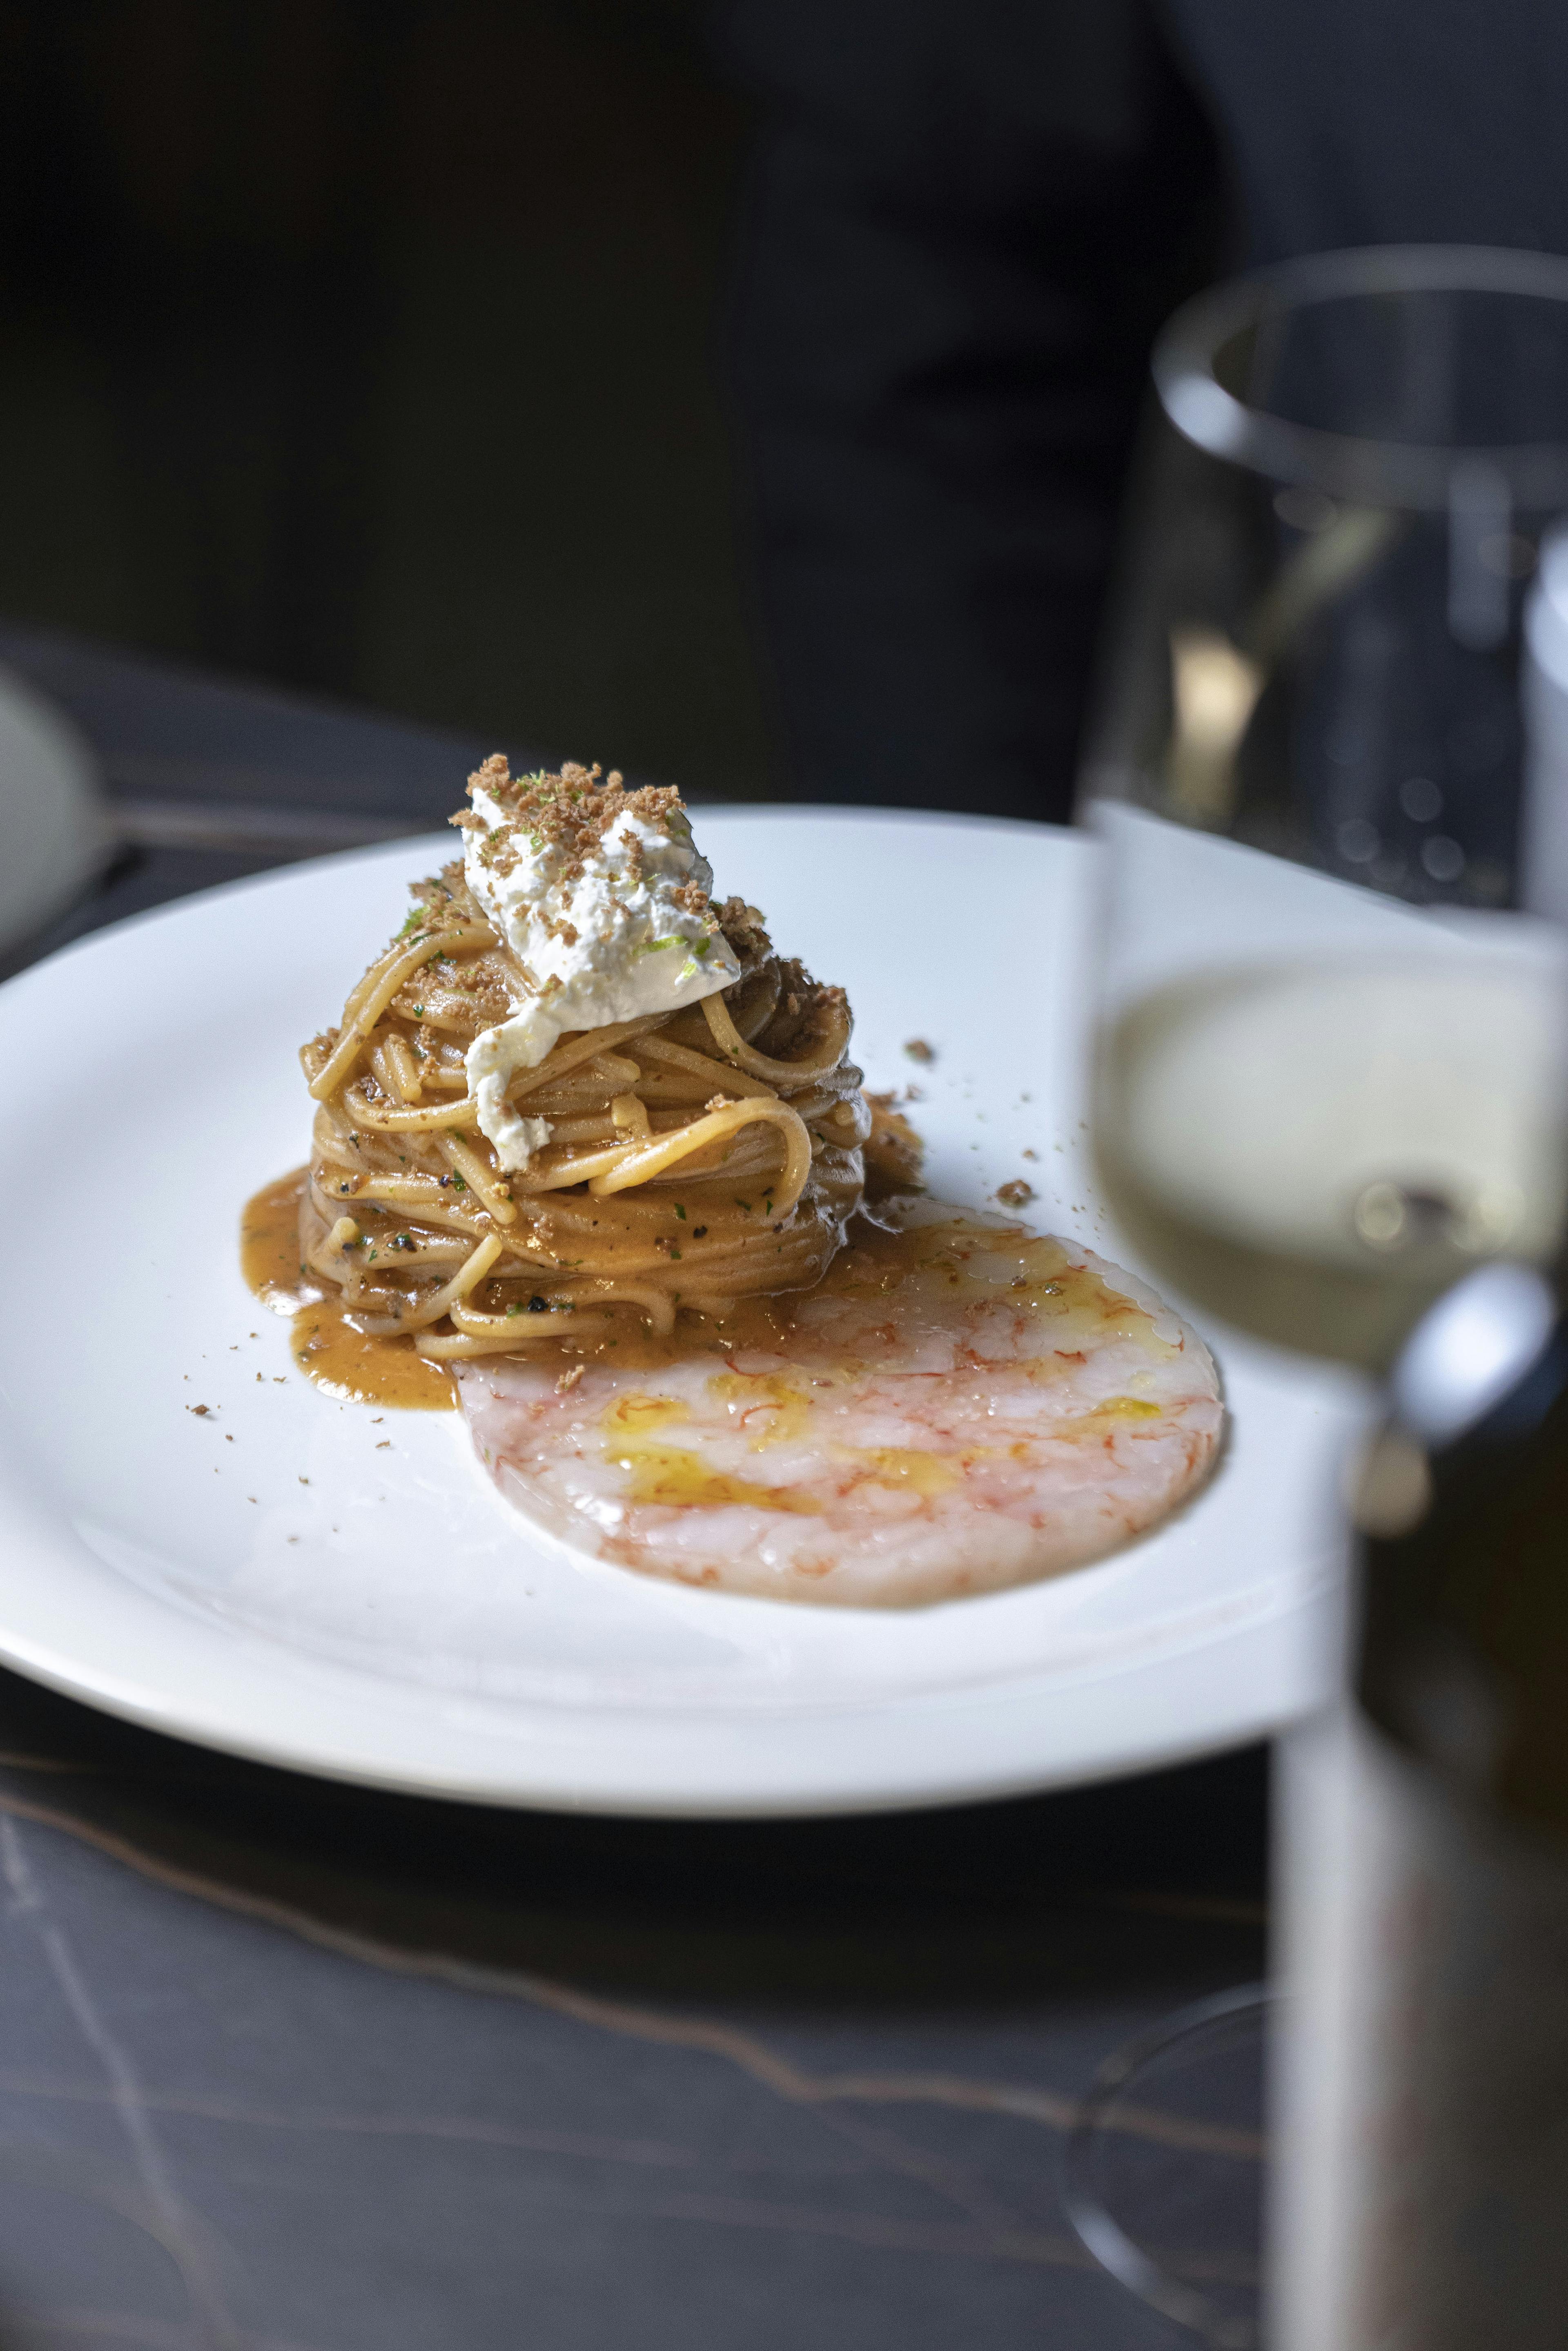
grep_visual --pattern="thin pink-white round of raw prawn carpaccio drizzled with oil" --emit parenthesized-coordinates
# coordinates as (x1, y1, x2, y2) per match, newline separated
(459, 1206, 1223, 1608)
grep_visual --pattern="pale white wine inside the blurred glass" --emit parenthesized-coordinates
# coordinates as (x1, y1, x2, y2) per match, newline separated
(1098, 926, 1563, 1370)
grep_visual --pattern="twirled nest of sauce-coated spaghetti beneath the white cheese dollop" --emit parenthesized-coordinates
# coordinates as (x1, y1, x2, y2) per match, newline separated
(301, 863, 870, 1359)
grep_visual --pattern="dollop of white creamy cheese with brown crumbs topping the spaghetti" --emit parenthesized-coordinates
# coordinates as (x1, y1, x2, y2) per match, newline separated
(463, 769, 740, 1171)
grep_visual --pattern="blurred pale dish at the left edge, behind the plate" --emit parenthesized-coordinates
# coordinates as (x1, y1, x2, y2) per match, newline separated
(0, 670, 111, 947)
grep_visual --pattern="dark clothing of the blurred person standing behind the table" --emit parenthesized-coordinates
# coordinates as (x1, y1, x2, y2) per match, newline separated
(722, 0, 1568, 818)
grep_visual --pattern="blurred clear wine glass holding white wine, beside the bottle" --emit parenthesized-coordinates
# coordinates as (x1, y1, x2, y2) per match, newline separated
(1069, 247, 1568, 2344)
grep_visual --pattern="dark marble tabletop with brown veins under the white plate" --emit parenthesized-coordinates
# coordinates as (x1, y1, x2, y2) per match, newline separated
(0, 630, 1265, 2351)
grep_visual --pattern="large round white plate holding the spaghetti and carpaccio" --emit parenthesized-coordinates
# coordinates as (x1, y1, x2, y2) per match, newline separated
(0, 809, 1363, 1815)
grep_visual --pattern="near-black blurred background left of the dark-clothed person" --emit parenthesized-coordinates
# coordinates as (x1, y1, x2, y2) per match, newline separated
(0, 0, 771, 792)
